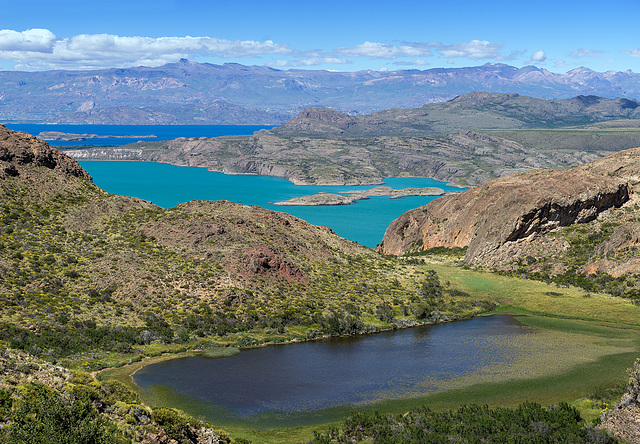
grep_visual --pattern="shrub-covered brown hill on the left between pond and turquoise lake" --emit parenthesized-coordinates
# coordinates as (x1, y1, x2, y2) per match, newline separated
(0, 126, 496, 367)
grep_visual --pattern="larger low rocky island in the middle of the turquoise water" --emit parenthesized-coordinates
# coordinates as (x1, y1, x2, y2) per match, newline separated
(274, 187, 445, 206)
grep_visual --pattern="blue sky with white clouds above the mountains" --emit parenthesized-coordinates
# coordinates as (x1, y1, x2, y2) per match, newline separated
(0, 0, 640, 72)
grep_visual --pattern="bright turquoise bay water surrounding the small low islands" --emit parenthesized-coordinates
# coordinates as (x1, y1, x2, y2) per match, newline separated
(80, 161, 459, 248)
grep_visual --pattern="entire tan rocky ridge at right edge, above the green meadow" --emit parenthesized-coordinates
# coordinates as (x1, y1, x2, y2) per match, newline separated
(380, 148, 640, 276)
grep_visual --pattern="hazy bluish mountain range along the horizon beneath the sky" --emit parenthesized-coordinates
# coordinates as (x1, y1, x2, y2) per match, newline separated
(0, 59, 640, 125)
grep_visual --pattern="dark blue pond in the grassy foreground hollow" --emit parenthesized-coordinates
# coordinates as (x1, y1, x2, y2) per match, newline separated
(134, 316, 532, 419)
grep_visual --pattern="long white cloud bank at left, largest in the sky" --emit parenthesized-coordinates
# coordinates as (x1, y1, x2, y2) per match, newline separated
(0, 29, 293, 69)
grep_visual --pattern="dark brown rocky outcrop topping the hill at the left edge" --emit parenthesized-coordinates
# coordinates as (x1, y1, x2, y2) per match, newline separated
(0, 125, 91, 180)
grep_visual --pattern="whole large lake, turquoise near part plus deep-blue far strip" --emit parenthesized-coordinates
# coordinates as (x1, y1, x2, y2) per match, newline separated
(2, 124, 459, 248)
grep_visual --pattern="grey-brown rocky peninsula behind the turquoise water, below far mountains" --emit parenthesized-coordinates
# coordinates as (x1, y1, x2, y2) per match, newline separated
(66, 92, 640, 187)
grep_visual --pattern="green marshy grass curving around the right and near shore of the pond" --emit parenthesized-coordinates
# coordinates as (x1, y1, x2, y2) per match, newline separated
(105, 261, 640, 443)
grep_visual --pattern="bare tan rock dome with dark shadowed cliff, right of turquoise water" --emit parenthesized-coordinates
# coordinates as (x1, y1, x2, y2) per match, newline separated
(381, 164, 630, 265)
